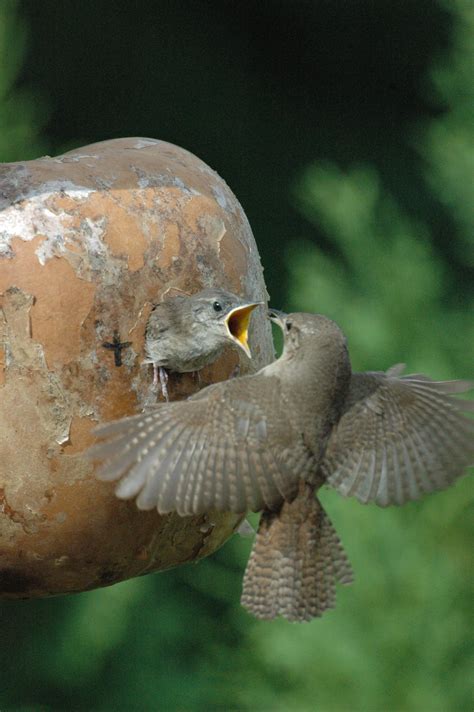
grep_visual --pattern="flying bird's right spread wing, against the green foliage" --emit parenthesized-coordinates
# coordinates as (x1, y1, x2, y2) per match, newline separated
(321, 366, 474, 506)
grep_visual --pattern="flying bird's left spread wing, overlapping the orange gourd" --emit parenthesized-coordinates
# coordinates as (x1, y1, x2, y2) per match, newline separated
(88, 379, 311, 515)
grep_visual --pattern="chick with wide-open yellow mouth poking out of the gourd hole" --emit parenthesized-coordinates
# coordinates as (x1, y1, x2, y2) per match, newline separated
(144, 289, 261, 400)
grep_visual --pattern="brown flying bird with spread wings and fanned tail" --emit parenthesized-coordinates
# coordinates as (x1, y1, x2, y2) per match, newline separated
(90, 312, 474, 621)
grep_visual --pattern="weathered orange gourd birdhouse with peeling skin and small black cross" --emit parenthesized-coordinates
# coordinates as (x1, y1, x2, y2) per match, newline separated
(0, 138, 273, 598)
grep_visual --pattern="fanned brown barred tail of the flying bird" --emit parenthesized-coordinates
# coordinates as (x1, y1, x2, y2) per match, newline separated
(241, 483, 353, 621)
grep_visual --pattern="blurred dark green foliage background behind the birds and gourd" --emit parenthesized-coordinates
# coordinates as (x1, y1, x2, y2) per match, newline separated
(0, 0, 474, 712)
